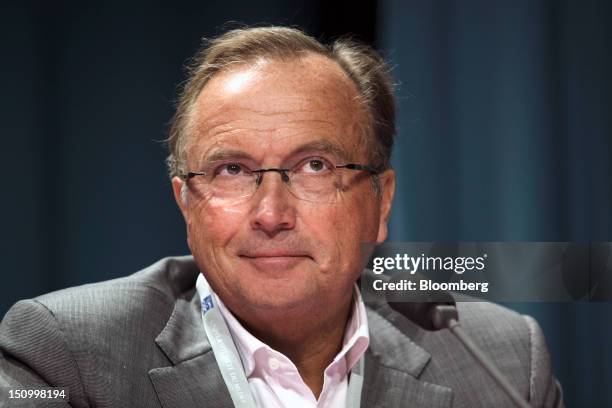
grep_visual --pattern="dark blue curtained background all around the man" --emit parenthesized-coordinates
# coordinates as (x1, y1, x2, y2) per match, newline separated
(0, 0, 612, 407)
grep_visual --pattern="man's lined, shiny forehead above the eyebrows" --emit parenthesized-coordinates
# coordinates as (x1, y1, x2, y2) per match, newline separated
(187, 55, 366, 163)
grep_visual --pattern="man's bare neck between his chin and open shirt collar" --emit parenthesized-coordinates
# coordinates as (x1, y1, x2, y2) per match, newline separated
(236, 296, 352, 398)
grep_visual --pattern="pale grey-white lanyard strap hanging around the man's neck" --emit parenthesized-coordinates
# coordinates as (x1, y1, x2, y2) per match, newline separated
(196, 273, 364, 408)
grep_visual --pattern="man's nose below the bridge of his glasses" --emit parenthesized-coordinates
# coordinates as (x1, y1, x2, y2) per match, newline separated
(250, 172, 296, 237)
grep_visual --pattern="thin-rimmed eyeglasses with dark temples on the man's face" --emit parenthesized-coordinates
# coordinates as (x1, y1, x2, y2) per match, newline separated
(180, 156, 381, 202)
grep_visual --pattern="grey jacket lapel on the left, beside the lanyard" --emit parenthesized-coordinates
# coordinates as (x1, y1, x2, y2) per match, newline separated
(149, 291, 233, 408)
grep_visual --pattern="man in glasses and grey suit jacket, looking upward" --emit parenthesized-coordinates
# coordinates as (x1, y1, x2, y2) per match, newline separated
(0, 27, 562, 407)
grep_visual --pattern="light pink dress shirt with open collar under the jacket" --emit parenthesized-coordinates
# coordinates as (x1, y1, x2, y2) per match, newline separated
(214, 285, 370, 408)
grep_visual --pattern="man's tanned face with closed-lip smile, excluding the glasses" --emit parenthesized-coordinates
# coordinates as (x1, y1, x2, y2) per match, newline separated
(173, 55, 394, 315)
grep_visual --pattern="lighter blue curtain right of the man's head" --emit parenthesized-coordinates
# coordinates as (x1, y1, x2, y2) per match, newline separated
(379, 0, 612, 407)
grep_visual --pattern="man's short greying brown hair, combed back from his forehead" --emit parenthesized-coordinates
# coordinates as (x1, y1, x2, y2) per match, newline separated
(166, 27, 395, 184)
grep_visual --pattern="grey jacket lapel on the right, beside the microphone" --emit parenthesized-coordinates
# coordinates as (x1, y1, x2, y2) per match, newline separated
(361, 304, 453, 408)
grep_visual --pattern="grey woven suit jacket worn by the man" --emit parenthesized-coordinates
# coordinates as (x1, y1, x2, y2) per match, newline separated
(0, 257, 563, 408)
